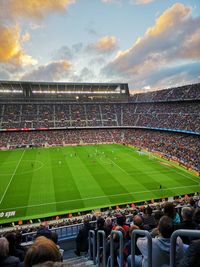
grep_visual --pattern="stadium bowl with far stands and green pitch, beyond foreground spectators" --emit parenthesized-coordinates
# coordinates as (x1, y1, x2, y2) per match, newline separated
(0, 81, 200, 266)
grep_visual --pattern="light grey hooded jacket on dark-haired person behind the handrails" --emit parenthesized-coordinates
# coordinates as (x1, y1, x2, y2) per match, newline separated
(137, 236, 183, 267)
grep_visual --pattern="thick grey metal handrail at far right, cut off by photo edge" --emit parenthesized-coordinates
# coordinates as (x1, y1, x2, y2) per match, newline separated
(170, 229, 200, 267)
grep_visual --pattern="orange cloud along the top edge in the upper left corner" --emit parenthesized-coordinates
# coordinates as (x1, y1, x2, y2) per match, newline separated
(0, 0, 76, 19)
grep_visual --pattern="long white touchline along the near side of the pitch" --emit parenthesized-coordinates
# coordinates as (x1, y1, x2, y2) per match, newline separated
(0, 184, 200, 211)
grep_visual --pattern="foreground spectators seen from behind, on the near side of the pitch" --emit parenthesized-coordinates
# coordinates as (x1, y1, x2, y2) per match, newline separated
(0, 194, 200, 267)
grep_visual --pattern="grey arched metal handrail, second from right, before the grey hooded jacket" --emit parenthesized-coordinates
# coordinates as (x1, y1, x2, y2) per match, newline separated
(131, 230, 152, 267)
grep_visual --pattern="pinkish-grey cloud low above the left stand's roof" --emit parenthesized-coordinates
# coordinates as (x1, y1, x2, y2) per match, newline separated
(21, 60, 71, 81)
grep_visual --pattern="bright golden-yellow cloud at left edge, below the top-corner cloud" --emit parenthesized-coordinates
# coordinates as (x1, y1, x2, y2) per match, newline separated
(0, 25, 37, 65)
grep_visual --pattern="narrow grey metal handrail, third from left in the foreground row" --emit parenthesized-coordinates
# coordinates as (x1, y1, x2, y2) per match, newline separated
(110, 230, 124, 267)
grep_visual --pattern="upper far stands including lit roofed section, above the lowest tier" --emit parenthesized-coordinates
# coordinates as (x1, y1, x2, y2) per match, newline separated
(0, 82, 200, 132)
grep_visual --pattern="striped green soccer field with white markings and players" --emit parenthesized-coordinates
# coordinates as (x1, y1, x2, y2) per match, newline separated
(0, 144, 200, 223)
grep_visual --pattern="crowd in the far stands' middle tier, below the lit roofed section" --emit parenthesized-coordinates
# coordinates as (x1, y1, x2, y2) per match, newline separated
(0, 101, 200, 132)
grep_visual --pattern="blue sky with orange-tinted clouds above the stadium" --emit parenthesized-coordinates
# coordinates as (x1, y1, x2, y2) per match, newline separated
(0, 0, 200, 92)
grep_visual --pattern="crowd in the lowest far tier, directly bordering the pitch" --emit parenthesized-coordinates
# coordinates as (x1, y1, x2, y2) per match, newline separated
(0, 129, 200, 171)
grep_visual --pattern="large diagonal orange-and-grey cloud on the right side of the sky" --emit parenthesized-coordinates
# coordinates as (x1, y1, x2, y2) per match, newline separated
(104, 3, 194, 73)
